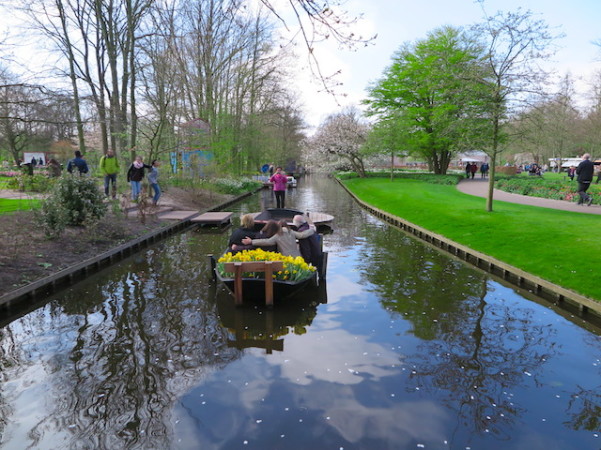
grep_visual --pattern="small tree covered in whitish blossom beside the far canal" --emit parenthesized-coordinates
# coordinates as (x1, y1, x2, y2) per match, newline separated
(308, 108, 369, 177)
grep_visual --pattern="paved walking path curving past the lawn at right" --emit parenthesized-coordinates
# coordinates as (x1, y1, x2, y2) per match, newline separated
(457, 178, 601, 214)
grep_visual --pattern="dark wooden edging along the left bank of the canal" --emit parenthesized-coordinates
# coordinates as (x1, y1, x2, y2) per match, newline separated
(0, 187, 262, 308)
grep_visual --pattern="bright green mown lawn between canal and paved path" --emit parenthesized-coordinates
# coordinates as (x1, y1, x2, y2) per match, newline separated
(344, 178, 601, 300)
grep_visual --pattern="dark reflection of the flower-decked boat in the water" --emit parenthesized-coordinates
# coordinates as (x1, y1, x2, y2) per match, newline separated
(217, 283, 327, 354)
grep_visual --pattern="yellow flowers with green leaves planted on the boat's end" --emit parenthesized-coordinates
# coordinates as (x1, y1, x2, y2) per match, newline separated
(217, 248, 316, 281)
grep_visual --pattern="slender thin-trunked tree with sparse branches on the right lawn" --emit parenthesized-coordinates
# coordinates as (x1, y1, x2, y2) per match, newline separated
(473, 5, 555, 212)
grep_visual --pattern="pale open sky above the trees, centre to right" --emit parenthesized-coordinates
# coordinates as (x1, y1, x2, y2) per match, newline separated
(297, 0, 601, 130)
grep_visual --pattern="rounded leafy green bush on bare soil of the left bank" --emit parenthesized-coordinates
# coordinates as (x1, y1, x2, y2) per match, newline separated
(39, 175, 107, 238)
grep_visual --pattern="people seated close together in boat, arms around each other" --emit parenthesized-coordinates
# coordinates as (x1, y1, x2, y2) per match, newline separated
(228, 214, 321, 267)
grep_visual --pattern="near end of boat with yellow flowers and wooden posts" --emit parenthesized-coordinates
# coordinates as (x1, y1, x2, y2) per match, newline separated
(210, 248, 317, 305)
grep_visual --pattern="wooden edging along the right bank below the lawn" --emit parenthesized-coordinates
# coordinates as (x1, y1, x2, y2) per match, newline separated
(336, 179, 601, 316)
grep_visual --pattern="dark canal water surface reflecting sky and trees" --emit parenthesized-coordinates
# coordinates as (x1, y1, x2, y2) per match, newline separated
(0, 177, 601, 450)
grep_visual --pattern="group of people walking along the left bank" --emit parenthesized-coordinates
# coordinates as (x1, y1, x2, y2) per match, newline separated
(58, 150, 161, 205)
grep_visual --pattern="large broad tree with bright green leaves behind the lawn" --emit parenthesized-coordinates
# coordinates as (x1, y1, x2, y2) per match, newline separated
(365, 27, 487, 174)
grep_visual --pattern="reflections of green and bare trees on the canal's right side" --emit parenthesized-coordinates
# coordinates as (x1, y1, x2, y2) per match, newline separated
(356, 229, 601, 440)
